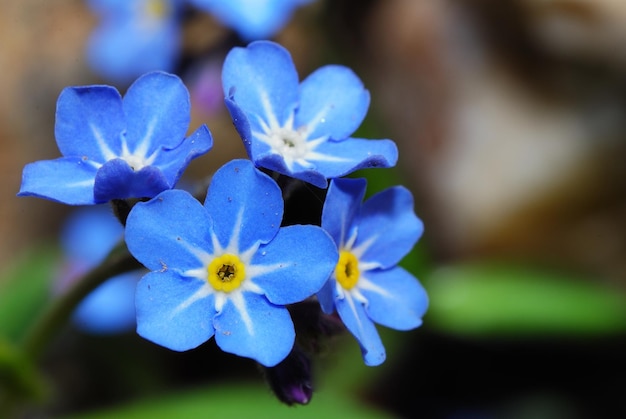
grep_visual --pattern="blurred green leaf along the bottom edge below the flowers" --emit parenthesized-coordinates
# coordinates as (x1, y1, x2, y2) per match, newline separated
(66, 383, 391, 419)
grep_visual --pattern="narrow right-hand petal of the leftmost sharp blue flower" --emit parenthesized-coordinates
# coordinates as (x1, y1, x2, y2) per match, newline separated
(153, 125, 213, 187)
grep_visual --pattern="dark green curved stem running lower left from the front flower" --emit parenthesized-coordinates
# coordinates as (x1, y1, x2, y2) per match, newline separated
(21, 241, 141, 360)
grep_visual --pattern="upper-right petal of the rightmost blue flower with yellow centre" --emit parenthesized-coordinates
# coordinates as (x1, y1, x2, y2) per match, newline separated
(354, 186, 424, 268)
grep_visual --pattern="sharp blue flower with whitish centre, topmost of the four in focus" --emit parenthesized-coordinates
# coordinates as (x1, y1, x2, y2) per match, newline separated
(222, 41, 398, 188)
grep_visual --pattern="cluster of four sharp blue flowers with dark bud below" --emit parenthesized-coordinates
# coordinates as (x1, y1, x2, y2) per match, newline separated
(19, 41, 428, 403)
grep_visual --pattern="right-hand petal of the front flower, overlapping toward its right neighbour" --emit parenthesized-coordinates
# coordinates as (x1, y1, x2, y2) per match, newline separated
(251, 225, 339, 305)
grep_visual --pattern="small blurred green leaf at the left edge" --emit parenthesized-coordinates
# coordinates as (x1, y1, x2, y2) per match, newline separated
(0, 246, 59, 342)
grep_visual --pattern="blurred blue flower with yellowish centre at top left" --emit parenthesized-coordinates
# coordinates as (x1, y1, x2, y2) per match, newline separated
(87, 0, 181, 83)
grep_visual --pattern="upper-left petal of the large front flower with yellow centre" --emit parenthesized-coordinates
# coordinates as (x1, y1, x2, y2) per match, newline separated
(125, 190, 213, 272)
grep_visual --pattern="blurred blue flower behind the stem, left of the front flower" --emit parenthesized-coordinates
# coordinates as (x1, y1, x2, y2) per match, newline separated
(56, 206, 141, 334)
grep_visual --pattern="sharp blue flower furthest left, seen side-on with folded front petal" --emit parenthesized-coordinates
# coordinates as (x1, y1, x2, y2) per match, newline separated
(18, 72, 213, 205)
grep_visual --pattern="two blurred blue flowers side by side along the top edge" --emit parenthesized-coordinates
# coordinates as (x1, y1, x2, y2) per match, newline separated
(87, 0, 311, 82)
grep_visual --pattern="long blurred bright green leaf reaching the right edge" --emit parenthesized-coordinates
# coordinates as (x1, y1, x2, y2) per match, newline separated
(424, 263, 626, 336)
